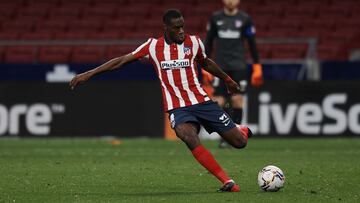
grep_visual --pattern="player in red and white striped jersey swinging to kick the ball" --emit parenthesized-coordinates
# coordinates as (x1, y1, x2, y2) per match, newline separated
(69, 9, 252, 192)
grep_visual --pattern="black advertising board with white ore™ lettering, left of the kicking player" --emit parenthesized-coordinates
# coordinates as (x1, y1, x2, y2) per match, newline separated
(0, 81, 163, 137)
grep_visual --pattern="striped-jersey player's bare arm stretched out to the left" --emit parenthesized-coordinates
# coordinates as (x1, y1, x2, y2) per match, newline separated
(69, 53, 137, 89)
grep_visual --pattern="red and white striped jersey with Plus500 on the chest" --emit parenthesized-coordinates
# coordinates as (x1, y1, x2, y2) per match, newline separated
(132, 35, 210, 111)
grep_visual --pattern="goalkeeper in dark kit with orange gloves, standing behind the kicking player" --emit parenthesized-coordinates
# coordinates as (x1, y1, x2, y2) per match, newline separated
(205, 0, 263, 147)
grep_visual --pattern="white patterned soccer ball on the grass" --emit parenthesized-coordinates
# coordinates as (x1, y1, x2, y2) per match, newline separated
(258, 165, 285, 192)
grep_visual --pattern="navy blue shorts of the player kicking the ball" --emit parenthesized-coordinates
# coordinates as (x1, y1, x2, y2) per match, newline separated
(169, 101, 236, 134)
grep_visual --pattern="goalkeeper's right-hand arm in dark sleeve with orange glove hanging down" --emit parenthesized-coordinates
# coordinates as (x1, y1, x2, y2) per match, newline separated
(245, 19, 264, 86)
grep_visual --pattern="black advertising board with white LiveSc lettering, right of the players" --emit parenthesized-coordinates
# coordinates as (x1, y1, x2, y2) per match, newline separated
(244, 81, 360, 136)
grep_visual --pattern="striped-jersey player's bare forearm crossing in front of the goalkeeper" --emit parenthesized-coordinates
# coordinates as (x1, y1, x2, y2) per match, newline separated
(198, 58, 240, 93)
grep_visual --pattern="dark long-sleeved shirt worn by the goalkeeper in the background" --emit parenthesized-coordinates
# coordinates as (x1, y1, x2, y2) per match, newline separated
(205, 10, 259, 70)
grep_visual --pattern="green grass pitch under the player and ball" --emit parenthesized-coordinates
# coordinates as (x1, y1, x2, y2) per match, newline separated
(0, 138, 360, 203)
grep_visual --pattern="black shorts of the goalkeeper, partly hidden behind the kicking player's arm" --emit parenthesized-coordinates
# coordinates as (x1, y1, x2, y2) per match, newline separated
(212, 68, 248, 96)
